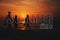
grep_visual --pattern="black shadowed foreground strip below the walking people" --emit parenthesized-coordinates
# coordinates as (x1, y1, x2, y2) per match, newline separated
(0, 30, 60, 40)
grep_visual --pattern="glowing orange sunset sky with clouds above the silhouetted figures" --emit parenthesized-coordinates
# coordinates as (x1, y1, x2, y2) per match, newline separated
(0, 0, 60, 18)
